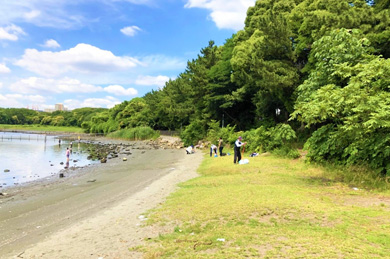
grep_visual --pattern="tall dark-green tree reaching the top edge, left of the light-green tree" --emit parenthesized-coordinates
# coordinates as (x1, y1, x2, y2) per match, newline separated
(231, 0, 299, 124)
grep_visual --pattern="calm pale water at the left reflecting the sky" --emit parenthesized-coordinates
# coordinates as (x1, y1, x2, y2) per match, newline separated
(0, 132, 93, 188)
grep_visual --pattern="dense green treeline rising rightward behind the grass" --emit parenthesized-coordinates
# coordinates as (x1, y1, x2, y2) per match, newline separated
(3, 0, 390, 173)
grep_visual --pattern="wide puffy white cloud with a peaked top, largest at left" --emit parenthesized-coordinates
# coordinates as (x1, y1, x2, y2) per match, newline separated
(15, 43, 141, 77)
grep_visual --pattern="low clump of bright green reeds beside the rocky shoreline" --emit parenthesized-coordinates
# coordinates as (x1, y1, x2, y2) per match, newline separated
(107, 127, 160, 140)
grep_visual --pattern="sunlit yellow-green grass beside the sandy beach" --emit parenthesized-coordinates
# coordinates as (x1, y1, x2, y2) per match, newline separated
(132, 150, 390, 258)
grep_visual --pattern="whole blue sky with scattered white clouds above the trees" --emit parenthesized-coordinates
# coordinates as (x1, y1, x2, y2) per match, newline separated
(0, 0, 255, 110)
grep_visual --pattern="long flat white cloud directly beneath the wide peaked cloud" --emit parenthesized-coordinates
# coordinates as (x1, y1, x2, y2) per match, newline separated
(9, 77, 103, 94)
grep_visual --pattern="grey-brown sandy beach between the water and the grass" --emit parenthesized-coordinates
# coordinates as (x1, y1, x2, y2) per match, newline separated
(0, 139, 203, 258)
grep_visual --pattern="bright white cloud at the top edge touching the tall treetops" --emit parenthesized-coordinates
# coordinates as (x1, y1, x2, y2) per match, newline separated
(184, 0, 256, 31)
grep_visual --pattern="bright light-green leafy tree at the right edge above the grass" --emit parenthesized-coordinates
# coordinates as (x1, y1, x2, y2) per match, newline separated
(293, 27, 390, 173)
